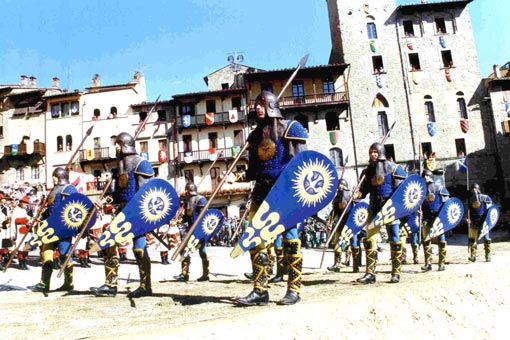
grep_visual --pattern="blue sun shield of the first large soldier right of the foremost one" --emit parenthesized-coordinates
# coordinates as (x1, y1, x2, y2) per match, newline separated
(367, 174, 426, 237)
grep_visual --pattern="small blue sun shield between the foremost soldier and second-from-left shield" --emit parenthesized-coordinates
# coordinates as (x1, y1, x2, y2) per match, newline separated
(182, 209, 224, 257)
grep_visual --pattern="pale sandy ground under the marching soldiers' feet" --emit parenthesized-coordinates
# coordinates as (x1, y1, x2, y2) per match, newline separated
(0, 232, 510, 340)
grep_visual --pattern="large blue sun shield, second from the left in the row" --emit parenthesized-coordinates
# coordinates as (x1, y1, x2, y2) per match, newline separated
(90, 178, 179, 252)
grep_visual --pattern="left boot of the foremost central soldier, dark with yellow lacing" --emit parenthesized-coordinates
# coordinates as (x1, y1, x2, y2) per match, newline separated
(236, 245, 269, 306)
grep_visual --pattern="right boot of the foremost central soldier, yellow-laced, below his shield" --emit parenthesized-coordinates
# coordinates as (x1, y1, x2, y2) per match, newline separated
(278, 239, 303, 305)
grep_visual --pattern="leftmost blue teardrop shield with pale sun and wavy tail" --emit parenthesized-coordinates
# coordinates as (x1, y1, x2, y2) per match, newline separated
(28, 192, 96, 248)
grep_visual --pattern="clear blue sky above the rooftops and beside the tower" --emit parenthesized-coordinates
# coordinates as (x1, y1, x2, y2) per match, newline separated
(0, 0, 510, 101)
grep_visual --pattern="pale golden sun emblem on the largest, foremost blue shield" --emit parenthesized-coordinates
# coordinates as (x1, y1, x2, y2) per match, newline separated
(292, 160, 334, 206)
